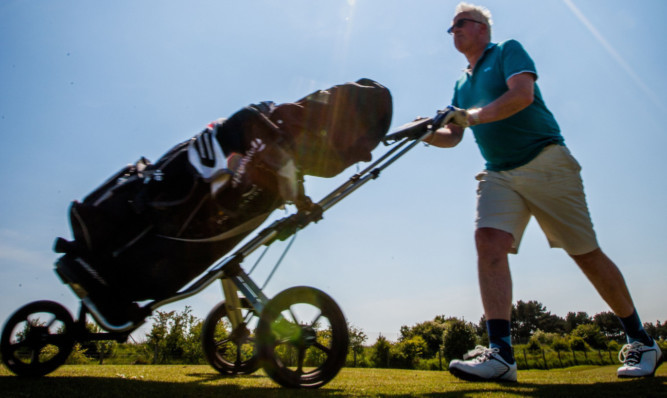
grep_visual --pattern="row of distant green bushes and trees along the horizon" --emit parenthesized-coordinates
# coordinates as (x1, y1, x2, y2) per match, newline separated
(44, 301, 667, 370)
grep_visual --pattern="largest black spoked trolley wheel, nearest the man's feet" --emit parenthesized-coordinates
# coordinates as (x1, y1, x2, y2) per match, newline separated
(257, 286, 349, 388)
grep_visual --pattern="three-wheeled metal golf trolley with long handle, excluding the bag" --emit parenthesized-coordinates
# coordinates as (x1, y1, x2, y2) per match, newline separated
(0, 107, 448, 388)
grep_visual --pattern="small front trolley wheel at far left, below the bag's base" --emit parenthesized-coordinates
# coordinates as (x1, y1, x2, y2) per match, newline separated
(0, 300, 74, 377)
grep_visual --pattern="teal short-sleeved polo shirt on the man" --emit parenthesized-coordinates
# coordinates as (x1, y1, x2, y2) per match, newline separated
(452, 40, 564, 171)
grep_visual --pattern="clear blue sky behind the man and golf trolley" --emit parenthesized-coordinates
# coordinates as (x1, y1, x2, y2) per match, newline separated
(0, 0, 667, 340)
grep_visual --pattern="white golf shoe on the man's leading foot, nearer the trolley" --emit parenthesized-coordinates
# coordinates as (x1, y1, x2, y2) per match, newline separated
(449, 346, 516, 382)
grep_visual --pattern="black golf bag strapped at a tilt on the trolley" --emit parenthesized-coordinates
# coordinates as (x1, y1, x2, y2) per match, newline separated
(56, 79, 392, 302)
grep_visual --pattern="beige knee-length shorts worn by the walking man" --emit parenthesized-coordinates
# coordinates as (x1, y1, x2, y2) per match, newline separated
(475, 145, 598, 255)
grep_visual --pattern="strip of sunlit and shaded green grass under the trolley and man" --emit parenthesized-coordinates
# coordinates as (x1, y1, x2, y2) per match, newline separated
(0, 365, 667, 398)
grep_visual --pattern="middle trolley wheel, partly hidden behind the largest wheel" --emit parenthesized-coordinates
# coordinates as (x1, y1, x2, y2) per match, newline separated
(202, 301, 259, 375)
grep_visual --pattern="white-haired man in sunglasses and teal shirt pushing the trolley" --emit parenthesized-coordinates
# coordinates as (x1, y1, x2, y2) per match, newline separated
(424, 3, 663, 381)
